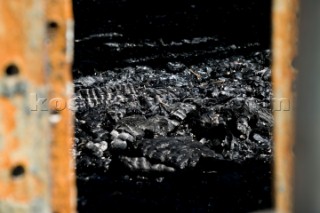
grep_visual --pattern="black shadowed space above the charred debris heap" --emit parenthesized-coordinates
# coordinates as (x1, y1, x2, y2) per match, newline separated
(74, 0, 271, 73)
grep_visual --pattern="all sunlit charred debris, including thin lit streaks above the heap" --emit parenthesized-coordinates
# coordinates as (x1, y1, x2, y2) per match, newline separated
(74, 33, 273, 178)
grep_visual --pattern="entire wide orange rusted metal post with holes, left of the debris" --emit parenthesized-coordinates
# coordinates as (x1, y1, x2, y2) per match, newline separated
(0, 0, 76, 213)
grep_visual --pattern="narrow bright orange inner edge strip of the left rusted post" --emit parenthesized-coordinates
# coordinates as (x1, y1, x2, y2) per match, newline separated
(46, 0, 76, 213)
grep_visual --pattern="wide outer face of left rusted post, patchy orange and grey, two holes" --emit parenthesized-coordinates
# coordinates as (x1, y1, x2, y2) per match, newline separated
(0, 0, 51, 213)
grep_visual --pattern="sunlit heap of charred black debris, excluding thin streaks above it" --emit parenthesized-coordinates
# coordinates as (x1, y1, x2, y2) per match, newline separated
(75, 47, 273, 169)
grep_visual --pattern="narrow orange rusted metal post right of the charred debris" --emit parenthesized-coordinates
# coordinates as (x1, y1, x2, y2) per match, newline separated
(272, 0, 298, 213)
